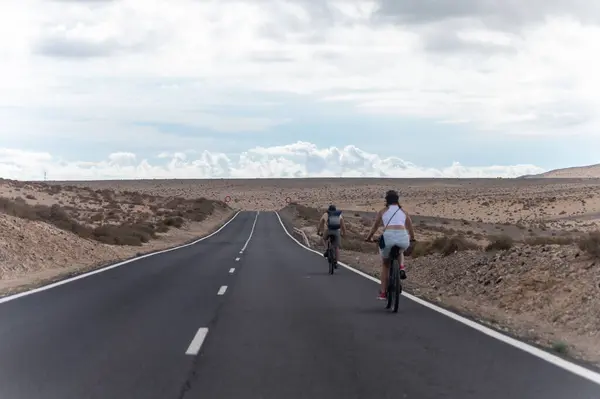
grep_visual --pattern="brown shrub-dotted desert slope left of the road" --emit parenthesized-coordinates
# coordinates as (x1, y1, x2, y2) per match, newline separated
(0, 179, 235, 296)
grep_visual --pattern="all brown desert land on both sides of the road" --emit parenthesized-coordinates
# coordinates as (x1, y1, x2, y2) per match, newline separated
(0, 178, 600, 365)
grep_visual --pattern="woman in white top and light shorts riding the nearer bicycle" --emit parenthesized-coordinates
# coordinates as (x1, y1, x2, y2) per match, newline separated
(365, 190, 415, 300)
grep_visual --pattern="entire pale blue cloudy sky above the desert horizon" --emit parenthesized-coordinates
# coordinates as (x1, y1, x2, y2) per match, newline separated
(0, 0, 600, 180)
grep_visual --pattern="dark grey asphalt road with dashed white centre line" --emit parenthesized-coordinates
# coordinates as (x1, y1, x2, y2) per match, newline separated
(0, 212, 600, 399)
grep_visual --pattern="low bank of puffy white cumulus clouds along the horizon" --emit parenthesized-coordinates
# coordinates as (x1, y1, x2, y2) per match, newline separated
(0, 142, 545, 180)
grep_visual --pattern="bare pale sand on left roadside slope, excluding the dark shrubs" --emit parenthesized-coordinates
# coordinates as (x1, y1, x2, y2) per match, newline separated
(0, 181, 235, 295)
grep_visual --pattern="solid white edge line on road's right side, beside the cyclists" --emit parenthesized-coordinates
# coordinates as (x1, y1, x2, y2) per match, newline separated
(275, 212, 600, 385)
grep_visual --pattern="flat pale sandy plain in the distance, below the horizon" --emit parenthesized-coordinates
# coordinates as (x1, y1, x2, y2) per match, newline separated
(50, 179, 600, 230)
